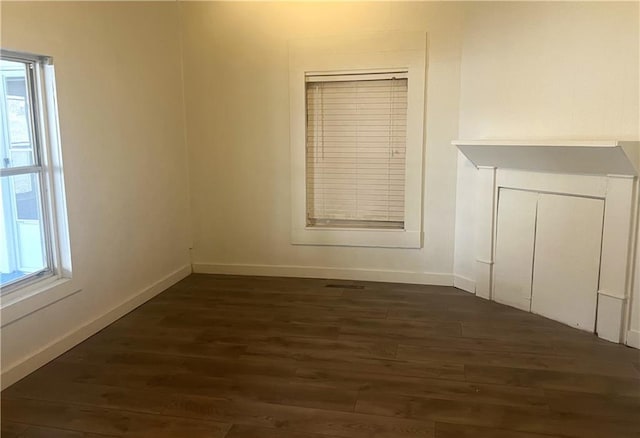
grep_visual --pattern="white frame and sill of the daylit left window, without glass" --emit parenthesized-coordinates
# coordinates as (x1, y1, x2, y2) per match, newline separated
(0, 49, 74, 326)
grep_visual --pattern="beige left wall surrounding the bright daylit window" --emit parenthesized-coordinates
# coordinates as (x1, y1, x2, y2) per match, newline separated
(1, 2, 189, 384)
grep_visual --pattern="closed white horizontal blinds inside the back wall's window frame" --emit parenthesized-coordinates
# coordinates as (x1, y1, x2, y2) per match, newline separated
(306, 74, 407, 228)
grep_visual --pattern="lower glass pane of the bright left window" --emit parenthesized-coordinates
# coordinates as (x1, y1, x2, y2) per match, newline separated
(0, 173, 48, 287)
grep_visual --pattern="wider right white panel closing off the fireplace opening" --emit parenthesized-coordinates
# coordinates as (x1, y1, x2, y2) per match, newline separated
(531, 193, 604, 332)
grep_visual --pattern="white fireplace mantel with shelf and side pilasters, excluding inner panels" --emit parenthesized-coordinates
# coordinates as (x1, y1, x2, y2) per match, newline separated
(453, 140, 640, 342)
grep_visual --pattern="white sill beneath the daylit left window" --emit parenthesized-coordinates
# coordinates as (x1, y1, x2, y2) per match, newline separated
(0, 277, 81, 327)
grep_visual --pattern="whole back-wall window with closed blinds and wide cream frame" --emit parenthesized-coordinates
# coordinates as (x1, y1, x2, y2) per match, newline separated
(290, 33, 426, 248)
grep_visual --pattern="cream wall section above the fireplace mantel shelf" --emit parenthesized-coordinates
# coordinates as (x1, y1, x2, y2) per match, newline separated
(460, 2, 640, 140)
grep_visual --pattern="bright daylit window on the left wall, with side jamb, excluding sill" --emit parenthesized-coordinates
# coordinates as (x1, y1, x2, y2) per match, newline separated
(0, 50, 68, 296)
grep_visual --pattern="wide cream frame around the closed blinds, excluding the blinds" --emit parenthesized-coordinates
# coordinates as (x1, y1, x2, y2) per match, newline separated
(289, 32, 427, 248)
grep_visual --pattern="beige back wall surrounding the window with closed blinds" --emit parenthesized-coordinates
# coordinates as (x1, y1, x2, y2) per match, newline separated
(181, 2, 463, 283)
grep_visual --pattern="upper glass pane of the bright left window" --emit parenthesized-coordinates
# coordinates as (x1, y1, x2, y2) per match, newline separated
(0, 60, 35, 167)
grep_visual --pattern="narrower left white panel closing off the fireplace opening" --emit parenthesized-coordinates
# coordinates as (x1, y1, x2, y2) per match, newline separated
(493, 188, 538, 312)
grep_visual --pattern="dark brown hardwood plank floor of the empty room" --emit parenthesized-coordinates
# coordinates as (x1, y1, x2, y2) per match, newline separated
(2, 275, 640, 438)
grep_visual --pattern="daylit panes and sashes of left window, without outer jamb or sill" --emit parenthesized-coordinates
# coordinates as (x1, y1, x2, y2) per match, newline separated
(0, 52, 52, 291)
